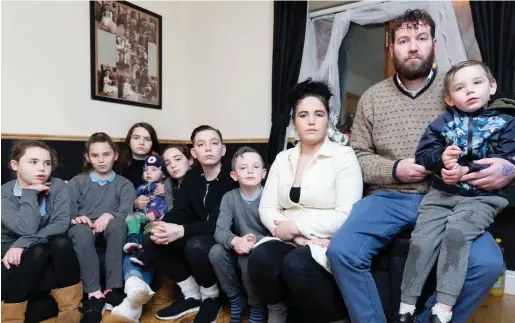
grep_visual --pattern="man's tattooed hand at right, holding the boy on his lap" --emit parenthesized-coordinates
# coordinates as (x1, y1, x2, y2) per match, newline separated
(461, 158, 515, 191)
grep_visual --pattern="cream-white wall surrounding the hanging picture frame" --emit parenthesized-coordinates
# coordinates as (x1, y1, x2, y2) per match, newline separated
(1, 1, 273, 139)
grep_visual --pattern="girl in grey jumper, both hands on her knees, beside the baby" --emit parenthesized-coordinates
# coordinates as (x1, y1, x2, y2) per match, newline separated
(68, 132, 135, 323)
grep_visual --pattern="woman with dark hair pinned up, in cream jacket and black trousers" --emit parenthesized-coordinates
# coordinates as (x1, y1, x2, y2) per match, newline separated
(248, 79, 363, 323)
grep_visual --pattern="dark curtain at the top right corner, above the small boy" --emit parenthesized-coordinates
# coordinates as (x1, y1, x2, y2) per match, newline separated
(470, 1, 515, 99)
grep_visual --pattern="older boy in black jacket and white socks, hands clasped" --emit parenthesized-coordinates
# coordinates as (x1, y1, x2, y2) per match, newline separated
(144, 125, 236, 323)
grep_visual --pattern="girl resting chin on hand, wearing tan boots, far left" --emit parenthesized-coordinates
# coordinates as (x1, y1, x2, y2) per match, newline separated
(1, 141, 82, 323)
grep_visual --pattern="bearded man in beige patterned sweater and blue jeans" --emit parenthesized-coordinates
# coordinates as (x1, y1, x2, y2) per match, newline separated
(327, 10, 515, 323)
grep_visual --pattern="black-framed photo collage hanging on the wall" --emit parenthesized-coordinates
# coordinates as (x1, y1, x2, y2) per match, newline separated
(90, 1, 163, 109)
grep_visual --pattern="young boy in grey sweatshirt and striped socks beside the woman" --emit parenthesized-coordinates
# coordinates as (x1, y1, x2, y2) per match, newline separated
(209, 147, 268, 323)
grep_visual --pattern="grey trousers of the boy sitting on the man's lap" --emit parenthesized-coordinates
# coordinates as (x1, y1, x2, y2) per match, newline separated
(401, 189, 508, 306)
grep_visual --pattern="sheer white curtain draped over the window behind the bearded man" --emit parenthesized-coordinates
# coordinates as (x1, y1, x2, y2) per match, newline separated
(299, 1, 467, 115)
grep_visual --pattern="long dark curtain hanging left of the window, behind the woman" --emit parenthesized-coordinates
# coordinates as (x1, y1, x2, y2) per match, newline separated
(267, 1, 307, 164)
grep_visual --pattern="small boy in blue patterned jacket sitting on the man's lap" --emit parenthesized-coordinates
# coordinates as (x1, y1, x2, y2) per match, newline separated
(399, 61, 515, 323)
